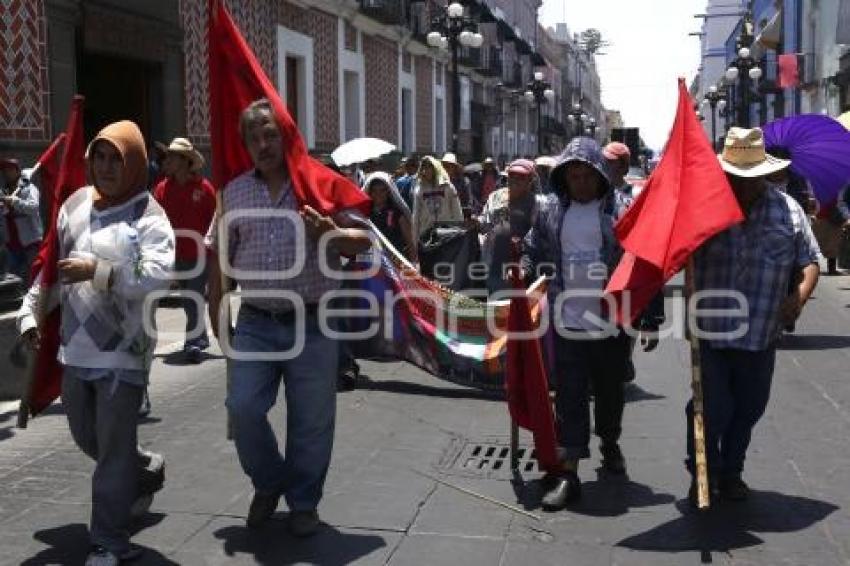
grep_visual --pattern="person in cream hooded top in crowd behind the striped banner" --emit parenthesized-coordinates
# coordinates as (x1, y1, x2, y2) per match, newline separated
(413, 156, 463, 240)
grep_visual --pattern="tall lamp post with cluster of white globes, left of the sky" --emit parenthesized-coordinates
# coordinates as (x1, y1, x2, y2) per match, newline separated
(427, 2, 484, 154)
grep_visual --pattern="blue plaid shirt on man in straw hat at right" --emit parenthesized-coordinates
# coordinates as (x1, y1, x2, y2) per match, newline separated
(695, 189, 820, 351)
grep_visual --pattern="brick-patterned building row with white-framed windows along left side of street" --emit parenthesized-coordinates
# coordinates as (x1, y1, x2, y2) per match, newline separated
(0, 0, 564, 169)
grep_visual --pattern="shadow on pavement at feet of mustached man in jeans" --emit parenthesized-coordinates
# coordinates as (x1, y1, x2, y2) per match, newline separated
(213, 515, 387, 566)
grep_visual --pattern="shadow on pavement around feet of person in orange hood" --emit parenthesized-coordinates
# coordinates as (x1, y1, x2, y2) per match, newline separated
(21, 513, 177, 566)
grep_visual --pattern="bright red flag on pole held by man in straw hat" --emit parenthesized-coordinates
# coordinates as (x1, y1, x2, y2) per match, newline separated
(606, 79, 744, 324)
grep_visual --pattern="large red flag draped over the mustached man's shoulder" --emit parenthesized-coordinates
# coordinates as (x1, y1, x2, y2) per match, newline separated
(208, 0, 371, 216)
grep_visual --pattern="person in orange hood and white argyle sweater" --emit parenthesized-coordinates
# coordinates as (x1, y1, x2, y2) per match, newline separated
(18, 121, 175, 565)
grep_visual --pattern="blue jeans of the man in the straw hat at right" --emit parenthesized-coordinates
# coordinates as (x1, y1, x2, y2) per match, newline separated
(685, 342, 776, 478)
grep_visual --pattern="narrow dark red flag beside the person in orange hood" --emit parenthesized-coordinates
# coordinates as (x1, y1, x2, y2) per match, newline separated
(26, 95, 86, 415)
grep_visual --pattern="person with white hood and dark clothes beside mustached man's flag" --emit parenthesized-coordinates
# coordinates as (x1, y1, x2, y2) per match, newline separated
(363, 171, 417, 262)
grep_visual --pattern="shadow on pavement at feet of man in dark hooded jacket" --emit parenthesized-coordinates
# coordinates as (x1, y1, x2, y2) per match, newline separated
(511, 468, 676, 517)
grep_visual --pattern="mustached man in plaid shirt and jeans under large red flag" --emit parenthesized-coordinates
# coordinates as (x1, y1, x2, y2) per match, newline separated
(209, 99, 371, 537)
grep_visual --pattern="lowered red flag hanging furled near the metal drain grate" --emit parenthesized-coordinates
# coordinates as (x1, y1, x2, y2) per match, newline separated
(505, 245, 559, 472)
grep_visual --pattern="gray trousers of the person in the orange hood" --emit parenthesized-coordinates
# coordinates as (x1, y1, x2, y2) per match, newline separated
(62, 376, 143, 556)
